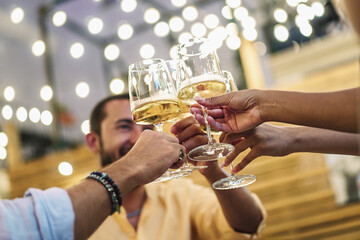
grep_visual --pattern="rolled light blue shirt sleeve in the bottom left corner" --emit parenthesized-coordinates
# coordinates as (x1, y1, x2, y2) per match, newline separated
(0, 188, 75, 240)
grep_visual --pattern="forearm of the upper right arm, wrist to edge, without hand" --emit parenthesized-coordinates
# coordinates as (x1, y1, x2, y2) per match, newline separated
(258, 88, 359, 133)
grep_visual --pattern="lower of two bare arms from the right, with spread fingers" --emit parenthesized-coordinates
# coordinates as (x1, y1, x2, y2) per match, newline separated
(220, 123, 360, 173)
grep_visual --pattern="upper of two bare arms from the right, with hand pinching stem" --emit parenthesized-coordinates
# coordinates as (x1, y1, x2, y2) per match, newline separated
(190, 88, 360, 133)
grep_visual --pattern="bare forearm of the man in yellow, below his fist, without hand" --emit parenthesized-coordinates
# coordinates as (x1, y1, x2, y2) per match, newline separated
(207, 169, 263, 234)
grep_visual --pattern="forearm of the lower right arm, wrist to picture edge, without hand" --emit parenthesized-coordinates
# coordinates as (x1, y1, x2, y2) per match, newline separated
(288, 127, 360, 155)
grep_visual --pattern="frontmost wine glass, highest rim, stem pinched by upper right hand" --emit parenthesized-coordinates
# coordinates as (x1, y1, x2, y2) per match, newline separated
(177, 38, 234, 161)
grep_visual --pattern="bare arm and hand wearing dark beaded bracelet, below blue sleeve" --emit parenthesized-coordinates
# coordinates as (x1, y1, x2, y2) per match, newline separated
(67, 130, 184, 239)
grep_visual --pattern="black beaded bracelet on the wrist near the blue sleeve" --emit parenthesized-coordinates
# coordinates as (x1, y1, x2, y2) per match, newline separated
(87, 172, 122, 214)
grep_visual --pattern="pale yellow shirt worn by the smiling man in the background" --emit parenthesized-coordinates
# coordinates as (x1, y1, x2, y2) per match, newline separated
(90, 179, 266, 240)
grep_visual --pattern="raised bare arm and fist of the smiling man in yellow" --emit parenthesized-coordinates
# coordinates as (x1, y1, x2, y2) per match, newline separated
(172, 117, 263, 233)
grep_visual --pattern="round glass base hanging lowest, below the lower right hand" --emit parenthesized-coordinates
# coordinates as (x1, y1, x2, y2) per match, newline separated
(212, 174, 256, 190)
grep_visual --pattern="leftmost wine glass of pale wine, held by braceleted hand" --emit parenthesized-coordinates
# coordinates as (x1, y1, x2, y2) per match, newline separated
(129, 58, 191, 182)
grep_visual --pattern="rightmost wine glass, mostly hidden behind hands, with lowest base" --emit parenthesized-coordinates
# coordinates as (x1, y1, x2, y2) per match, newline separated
(212, 70, 256, 190)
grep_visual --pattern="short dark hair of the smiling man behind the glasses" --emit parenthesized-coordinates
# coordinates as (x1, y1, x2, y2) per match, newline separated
(90, 93, 129, 135)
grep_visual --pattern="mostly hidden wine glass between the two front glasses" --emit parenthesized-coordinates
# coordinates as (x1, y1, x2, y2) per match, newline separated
(165, 60, 207, 171)
